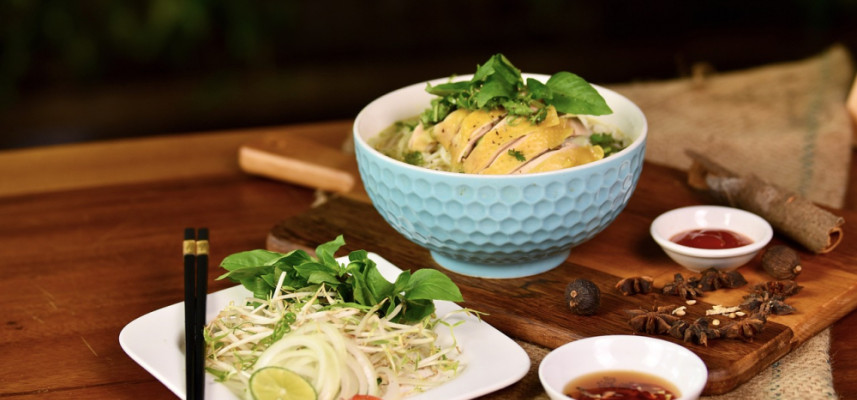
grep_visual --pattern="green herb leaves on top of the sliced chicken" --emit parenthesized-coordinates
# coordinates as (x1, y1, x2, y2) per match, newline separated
(420, 54, 613, 126)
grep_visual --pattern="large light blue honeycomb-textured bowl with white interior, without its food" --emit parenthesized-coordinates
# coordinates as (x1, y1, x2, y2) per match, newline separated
(354, 74, 647, 278)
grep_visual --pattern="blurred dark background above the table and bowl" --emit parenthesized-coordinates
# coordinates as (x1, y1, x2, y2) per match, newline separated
(0, 0, 857, 149)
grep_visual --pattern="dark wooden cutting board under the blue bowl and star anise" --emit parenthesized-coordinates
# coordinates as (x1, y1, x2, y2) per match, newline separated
(247, 134, 857, 395)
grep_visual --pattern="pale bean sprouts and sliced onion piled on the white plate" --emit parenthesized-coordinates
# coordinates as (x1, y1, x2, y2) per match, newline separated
(205, 276, 466, 400)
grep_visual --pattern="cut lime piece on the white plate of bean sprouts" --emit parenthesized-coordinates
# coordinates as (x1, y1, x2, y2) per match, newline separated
(250, 367, 318, 400)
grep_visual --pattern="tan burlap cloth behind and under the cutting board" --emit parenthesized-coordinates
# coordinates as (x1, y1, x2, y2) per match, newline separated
(498, 45, 854, 400)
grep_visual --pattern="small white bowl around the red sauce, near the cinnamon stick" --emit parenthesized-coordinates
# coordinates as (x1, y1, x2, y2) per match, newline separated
(650, 206, 774, 272)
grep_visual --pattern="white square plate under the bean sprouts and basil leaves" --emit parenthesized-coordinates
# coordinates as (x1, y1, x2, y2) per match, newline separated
(119, 253, 530, 400)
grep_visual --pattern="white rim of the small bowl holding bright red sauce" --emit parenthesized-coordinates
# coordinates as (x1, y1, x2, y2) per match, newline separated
(649, 205, 774, 258)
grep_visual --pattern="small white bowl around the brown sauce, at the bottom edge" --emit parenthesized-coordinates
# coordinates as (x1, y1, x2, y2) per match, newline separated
(539, 335, 708, 400)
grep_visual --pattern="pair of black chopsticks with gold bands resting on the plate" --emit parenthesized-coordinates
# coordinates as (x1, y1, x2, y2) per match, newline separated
(182, 228, 208, 400)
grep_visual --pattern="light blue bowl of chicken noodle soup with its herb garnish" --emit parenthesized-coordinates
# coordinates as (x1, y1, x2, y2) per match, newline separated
(353, 54, 647, 278)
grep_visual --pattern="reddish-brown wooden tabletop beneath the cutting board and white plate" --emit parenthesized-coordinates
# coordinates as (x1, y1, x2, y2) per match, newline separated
(0, 121, 857, 399)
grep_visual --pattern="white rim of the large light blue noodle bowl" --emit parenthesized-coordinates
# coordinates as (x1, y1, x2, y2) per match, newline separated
(352, 73, 649, 180)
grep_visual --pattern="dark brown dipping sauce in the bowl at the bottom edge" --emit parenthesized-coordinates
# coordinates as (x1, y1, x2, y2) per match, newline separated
(562, 370, 681, 400)
